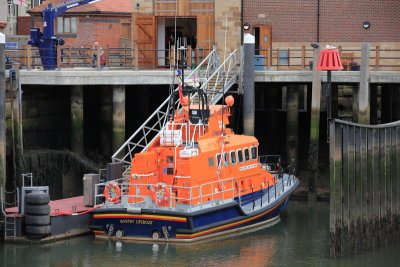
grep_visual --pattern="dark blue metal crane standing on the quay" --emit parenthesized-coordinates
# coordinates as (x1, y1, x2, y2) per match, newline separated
(28, 0, 101, 70)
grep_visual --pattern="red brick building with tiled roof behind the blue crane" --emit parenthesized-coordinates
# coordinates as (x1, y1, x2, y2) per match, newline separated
(28, 0, 132, 47)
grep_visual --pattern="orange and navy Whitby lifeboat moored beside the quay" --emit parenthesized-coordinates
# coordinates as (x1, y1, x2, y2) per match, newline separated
(91, 66, 299, 242)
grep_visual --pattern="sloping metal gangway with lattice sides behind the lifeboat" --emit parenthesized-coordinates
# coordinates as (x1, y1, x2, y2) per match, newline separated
(112, 48, 240, 170)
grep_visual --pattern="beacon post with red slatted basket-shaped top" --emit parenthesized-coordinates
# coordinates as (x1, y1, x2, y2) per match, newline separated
(316, 45, 343, 142)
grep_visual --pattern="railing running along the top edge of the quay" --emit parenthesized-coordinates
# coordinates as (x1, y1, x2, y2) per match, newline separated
(6, 45, 400, 71)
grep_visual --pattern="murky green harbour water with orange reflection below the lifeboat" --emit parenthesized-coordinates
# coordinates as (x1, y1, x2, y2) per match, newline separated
(0, 201, 400, 267)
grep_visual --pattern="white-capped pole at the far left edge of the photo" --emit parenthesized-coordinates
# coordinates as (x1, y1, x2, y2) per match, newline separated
(0, 33, 6, 188)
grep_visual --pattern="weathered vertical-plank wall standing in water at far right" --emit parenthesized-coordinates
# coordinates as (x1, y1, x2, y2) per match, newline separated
(330, 120, 400, 256)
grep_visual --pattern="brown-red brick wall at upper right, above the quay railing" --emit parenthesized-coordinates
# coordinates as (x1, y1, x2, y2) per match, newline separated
(243, 0, 400, 42)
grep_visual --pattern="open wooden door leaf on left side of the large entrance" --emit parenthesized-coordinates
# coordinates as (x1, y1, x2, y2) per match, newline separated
(134, 16, 156, 68)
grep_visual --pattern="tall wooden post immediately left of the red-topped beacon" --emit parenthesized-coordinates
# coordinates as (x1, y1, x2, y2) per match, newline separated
(308, 47, 321, 201)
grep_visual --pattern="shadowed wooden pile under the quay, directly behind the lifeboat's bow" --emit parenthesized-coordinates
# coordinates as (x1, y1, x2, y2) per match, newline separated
(286, 84, 299, 175)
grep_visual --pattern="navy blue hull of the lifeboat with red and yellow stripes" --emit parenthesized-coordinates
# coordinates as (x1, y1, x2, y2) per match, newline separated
(91, 197, 289, 242)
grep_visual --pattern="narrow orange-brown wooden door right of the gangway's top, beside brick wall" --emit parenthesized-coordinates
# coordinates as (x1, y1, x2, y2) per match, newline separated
(253, 24, 272, 66)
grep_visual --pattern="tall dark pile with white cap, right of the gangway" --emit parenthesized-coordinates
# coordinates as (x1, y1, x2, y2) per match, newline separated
(243, 33, 255, 136)
